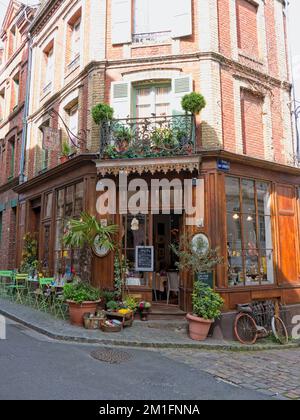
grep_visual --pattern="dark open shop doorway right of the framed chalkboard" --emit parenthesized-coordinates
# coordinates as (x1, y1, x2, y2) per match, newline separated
(153, 213, 182, 306)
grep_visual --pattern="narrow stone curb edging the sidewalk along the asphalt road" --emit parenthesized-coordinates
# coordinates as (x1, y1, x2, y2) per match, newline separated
(0, 308, 300, 352)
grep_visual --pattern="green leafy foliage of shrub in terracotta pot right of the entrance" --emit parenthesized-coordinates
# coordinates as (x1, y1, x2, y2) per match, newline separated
(192, 281, 224, 320)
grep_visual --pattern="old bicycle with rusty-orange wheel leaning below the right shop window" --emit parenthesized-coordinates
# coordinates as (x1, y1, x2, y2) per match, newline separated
(234, 301, 289, 345)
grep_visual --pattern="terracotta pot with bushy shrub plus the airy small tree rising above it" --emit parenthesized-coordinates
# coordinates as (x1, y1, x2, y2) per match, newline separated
(171, 236, 223, 340)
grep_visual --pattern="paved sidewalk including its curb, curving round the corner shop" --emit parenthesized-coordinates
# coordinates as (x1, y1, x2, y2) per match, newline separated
(0, 299, 299, 351)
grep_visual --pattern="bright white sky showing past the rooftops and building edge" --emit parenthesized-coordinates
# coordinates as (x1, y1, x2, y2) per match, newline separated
(0, 0, 300, 100)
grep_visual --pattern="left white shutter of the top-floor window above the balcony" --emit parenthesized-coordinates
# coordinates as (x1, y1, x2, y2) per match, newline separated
(111, 0, 132, 45)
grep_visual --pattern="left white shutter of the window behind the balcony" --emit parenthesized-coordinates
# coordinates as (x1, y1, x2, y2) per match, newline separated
(111, 82, 131, 119)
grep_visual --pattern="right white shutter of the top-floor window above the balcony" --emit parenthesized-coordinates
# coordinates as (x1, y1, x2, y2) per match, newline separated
(172, 0, 192, 38)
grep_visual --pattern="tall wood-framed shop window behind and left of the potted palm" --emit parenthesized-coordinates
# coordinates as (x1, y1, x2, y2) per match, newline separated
(54, 182, 84, 275)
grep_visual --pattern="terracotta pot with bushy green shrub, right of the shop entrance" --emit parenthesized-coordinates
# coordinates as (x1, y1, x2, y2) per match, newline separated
(186, 281, 224, 341)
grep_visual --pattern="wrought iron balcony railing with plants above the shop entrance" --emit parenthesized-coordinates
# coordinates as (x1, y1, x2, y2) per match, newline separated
(100, 115, 195, 159)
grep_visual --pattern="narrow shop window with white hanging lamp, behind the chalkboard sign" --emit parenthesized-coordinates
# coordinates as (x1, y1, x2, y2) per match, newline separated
(122, 215, 149, 287)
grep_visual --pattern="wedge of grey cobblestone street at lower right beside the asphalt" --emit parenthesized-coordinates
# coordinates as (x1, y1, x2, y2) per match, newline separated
(162, 349, 300, 400)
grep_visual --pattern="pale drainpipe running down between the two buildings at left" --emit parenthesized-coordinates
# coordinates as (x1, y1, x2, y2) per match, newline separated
(19, 7, 32, 184)
